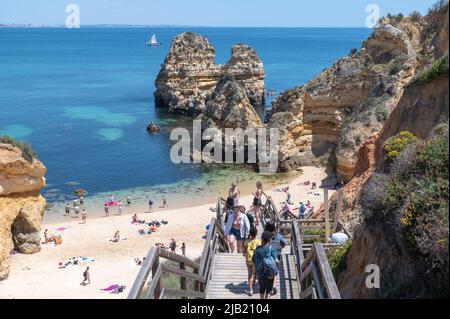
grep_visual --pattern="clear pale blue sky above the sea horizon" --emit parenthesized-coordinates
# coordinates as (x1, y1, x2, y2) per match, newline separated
(0, 0, 436, 27)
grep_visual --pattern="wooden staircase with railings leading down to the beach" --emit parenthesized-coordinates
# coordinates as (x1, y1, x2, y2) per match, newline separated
(128, 199, 340, 299)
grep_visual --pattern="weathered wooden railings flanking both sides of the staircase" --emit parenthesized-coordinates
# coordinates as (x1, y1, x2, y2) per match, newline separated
(128, 199, 340, 299)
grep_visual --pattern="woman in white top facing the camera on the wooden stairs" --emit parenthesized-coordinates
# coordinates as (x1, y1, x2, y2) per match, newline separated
(225, 206, 250, 254)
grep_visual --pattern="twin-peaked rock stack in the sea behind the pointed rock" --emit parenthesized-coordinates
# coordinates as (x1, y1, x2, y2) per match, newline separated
(155, 32, 265, 116)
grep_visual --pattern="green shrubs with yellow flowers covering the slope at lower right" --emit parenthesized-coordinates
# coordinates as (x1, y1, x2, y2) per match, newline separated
(362, 124, 449, 298)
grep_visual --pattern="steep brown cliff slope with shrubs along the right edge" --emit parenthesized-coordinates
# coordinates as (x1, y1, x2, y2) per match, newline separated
(320, 5, 449, 298)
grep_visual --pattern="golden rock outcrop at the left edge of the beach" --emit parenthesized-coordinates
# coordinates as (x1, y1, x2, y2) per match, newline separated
(0, 144, 46, 280)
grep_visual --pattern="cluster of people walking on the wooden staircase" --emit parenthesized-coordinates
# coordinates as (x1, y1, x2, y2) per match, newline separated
(225, 182, 286, 299)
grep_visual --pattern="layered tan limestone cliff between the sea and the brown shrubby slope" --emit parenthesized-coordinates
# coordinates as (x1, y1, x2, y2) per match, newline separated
(268, 12, 445, 182)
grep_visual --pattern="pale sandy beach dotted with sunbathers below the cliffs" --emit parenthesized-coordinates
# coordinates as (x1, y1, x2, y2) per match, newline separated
(0, 167, 332, 299)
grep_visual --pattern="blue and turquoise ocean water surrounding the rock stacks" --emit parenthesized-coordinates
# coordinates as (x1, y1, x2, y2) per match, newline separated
(0, 28, 371, 216)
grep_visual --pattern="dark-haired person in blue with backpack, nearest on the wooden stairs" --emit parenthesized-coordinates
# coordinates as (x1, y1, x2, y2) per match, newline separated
(253, 231, 278, 299)
